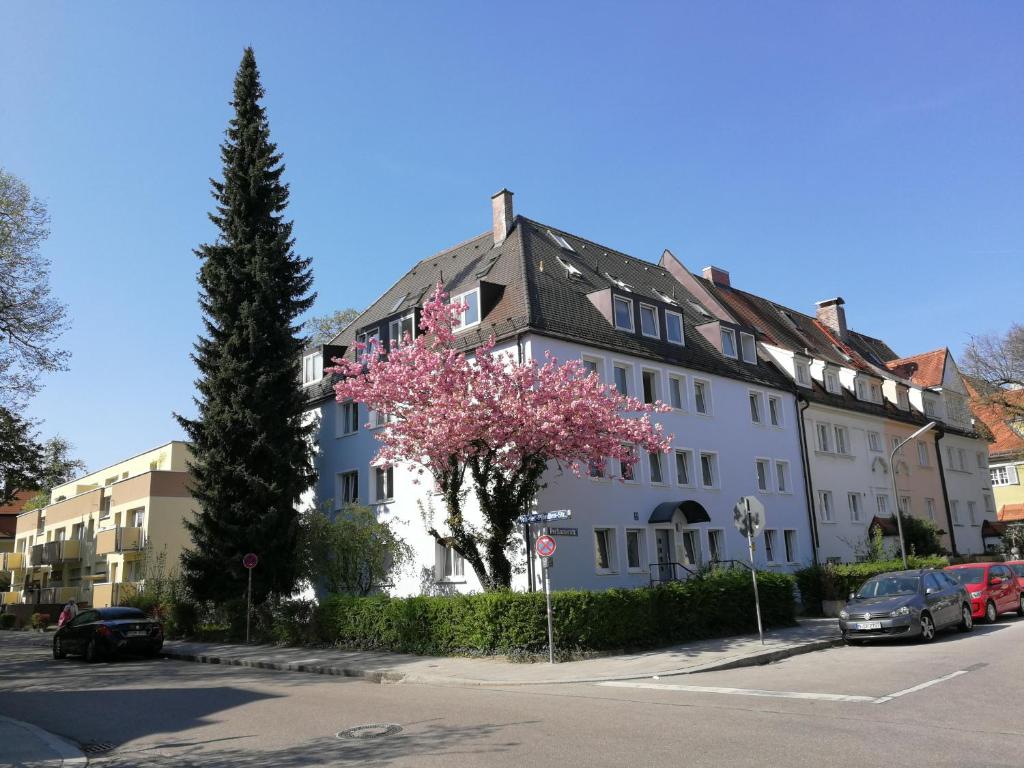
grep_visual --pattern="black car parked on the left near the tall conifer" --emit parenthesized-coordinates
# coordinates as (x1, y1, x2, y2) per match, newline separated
(53, 608, 164, 662)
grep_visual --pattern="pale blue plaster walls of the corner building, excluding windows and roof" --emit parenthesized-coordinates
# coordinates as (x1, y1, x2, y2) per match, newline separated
(303, 335, 812, 595)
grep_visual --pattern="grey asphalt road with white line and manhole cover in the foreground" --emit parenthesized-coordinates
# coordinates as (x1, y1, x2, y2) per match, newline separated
(0, 616, 1024, 768)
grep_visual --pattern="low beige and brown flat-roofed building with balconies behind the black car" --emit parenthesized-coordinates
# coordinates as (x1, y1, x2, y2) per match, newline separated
(0, 441, 195, 607)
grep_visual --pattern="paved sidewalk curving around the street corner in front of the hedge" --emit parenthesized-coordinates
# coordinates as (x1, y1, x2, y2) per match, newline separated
(164, 618, 842, 686)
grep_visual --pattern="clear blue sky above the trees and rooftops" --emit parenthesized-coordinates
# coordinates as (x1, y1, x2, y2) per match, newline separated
(0, 1, 1024, 468)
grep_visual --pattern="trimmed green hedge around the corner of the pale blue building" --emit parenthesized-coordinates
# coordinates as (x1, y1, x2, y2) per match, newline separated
(315, 570, 796, 655)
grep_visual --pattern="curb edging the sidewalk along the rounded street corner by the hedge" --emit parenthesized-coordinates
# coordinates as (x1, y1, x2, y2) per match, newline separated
(163, 637, 843, 688)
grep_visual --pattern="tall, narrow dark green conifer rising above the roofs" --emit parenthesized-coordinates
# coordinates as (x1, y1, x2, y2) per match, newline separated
(177, 48, 315, 602)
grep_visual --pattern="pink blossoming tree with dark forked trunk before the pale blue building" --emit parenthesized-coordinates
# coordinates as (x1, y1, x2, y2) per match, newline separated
(333, 284, 671, 590)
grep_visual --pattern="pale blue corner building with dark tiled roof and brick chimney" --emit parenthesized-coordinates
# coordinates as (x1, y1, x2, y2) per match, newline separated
(304, 190, 813, 594)
